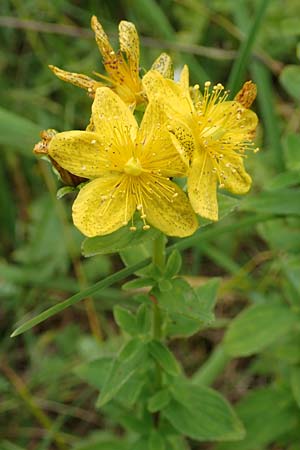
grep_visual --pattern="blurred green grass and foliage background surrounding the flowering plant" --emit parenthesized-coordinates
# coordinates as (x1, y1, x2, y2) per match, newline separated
(0, 0, 300, 450)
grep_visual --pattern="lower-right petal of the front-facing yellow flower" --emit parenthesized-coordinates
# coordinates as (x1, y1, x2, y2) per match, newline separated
(145, 179, 198, 237)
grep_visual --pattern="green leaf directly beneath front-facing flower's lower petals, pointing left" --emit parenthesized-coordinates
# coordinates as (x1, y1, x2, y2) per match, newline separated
(82, 222, 160, 257)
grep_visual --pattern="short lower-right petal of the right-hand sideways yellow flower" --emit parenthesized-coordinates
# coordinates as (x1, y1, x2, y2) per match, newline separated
(219, 156, 252, 194)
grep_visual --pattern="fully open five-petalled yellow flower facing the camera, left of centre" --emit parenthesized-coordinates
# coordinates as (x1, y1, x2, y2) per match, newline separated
(49, 87, 198, 237)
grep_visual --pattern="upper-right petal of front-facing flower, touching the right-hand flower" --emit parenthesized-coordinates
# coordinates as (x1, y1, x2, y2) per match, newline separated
(137, 99, 188, 177)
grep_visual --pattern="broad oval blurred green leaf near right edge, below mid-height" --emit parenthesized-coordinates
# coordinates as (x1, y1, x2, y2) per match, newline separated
(224, 304, 298, 356)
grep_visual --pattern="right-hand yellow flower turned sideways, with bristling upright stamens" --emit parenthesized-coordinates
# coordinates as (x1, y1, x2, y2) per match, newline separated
(143, 66, 257, 220)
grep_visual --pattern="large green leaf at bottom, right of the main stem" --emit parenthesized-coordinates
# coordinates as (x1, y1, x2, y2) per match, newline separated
(162, 383, 244, 441)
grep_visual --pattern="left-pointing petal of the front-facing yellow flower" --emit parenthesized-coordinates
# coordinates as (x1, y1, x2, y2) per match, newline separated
(49, 131, 107, 178)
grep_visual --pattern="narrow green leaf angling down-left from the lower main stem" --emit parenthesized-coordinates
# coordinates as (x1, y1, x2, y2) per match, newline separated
(97, 339, 147, 407)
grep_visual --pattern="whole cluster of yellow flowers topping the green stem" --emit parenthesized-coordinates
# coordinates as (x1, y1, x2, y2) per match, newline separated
(35, 17, 257, 237)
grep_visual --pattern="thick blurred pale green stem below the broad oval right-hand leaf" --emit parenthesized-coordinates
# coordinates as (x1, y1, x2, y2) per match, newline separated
(192, 344, 230, 386)
